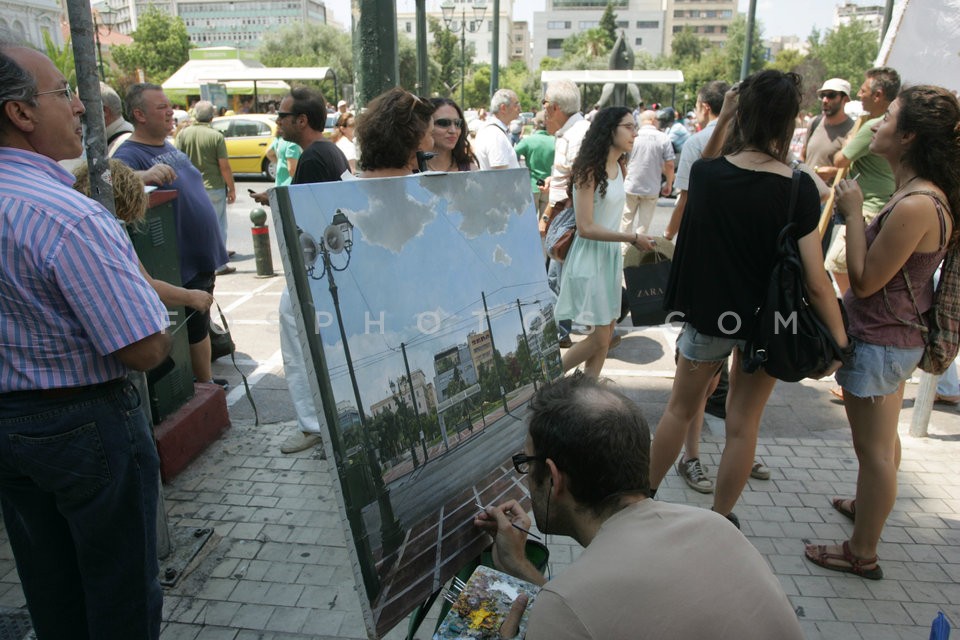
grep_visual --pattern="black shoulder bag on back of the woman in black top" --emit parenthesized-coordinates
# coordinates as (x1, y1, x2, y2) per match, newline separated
(742, 169, 846, 382)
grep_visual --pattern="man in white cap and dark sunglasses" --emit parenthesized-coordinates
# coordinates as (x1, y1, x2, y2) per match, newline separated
(800, 78, 854, 184)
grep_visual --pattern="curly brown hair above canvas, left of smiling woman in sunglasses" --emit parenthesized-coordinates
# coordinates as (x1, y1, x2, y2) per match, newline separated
(354, 87, 434, 171)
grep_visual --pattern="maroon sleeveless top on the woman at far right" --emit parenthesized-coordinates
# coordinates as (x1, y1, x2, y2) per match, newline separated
(843, 191, 949, 349)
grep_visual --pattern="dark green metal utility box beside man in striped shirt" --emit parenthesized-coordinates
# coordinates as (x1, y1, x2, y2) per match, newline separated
(130, 191, 193, 425)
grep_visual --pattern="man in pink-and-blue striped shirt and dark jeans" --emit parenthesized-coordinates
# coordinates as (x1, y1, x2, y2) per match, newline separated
(0, 36, 170, 640)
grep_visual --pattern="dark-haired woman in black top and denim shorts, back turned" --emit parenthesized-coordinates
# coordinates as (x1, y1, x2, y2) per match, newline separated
(650, 70, 847, 523)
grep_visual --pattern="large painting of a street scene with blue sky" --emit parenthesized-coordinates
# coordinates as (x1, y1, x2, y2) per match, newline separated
(271, 169, 561, 637)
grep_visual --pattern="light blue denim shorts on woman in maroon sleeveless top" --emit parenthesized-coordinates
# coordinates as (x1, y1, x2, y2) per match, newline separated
(835, 338, 923, 398)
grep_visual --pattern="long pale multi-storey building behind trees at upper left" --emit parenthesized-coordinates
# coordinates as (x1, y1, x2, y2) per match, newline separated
(95, 0, 327, 49)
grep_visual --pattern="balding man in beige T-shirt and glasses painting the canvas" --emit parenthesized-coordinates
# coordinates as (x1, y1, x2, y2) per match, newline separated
(474, 373, 803, 640)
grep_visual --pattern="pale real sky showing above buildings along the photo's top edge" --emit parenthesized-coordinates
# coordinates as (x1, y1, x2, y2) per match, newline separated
(326, 0, 848, 38)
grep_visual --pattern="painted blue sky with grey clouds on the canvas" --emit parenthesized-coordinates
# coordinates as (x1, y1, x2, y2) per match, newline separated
(290, 169, 553, 410)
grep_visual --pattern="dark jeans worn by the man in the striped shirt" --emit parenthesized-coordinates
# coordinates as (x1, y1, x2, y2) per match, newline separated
(0, 380, 163, 640)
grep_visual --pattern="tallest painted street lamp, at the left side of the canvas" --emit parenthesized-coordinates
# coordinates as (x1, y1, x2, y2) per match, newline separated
(300, 209, 403, 557)
